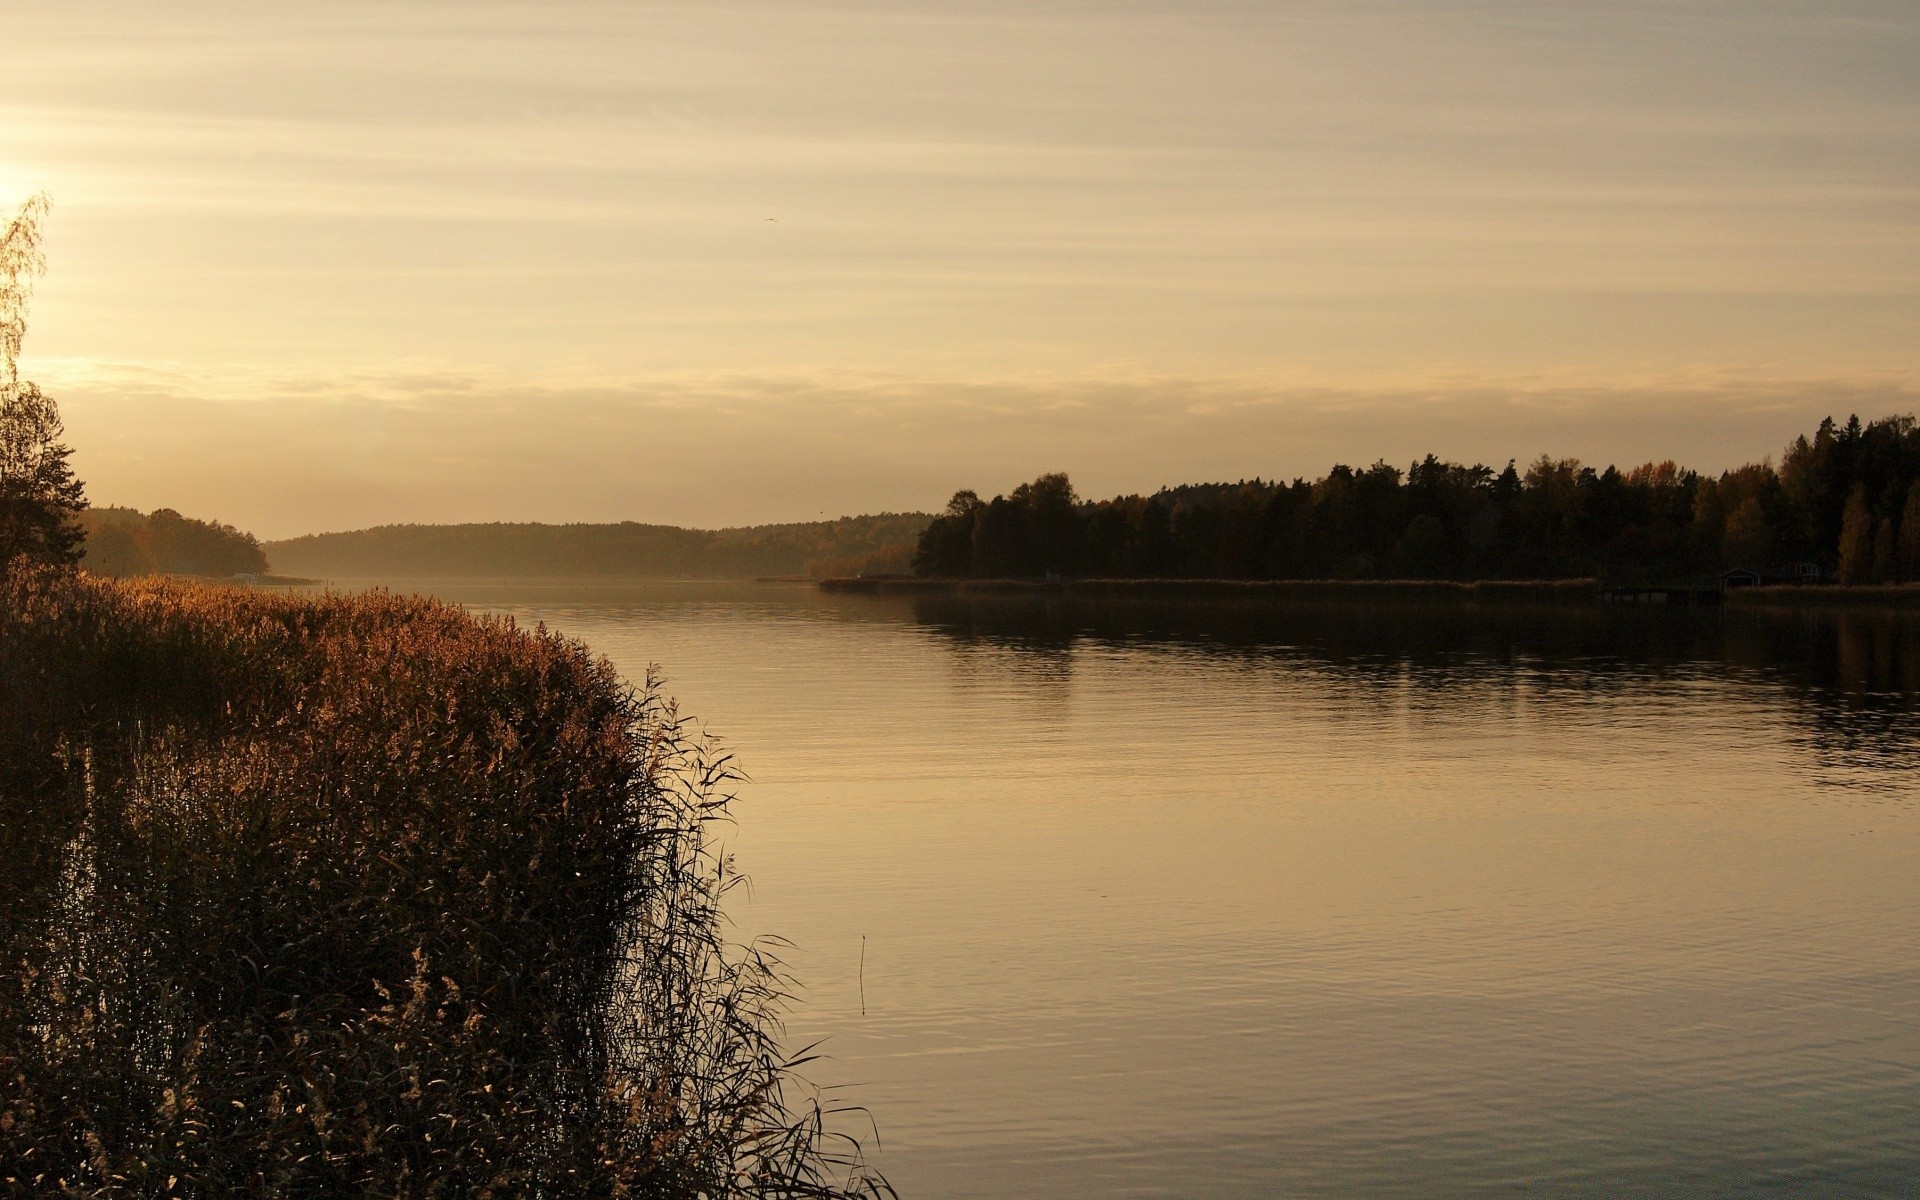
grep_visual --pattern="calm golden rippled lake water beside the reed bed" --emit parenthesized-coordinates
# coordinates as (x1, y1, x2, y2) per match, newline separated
(420, 586, 1920, 1198)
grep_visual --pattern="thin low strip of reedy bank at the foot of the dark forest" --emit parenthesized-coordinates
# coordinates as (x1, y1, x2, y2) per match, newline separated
(820, 578, 1596, 601)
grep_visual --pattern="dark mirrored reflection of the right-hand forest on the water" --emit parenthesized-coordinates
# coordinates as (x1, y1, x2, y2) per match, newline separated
(910, 597, 1920, 785)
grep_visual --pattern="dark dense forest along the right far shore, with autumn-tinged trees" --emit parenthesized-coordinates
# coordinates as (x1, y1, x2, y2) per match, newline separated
(914, 417, 1920, 584)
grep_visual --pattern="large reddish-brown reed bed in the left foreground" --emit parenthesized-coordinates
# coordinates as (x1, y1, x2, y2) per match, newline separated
(0, 570, 885, 1198)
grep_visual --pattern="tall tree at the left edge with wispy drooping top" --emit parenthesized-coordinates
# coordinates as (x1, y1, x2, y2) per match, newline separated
(0, 194, 86, 570)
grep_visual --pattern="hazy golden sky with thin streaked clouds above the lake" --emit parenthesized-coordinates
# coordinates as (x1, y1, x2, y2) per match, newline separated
(0, 0, 1920, 536)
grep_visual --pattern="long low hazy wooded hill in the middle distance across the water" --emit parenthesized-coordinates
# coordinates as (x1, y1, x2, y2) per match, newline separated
(265, 513, 933, 580)
